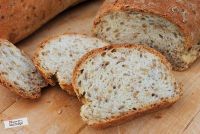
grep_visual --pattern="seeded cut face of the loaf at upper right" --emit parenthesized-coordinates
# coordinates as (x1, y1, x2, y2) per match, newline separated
(94, 2, 200, 71)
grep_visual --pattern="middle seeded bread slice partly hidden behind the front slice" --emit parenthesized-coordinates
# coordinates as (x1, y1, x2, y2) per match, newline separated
(34, 34, 107, 95)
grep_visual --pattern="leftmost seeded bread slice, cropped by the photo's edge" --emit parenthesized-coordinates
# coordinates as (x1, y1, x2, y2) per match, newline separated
(0, 39, 47, 99)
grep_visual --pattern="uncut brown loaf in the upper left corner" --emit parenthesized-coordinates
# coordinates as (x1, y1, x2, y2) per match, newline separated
(0, 0, 84, 43)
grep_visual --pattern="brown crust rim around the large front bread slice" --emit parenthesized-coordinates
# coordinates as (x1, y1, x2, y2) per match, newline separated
(72, 45, 182, 128)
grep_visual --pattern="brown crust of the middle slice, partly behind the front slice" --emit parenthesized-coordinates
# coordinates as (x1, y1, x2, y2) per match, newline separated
(33, 33, 106, 96)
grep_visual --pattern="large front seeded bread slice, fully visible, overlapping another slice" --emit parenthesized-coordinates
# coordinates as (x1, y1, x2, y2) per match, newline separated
(72, 45, 182, 128)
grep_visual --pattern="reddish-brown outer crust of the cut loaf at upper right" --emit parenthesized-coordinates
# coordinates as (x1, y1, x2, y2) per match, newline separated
(93, 0, 200, 48)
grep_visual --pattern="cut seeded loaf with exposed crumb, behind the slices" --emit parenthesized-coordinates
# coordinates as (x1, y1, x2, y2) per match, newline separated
(93, 0, 200, 71)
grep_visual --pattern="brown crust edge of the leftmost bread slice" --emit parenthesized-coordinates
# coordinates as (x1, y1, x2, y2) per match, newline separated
(0, 39, 41, 99)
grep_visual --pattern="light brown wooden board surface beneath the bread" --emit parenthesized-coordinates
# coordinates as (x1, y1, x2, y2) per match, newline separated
(0, 0, 200, 134)
